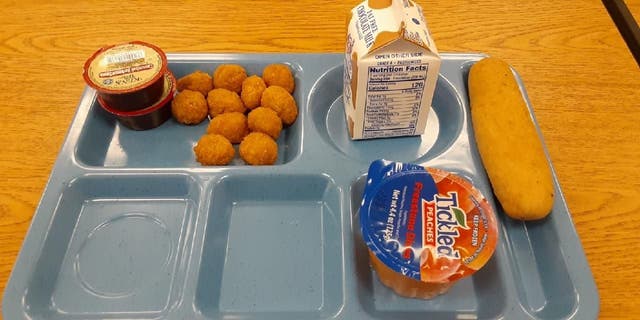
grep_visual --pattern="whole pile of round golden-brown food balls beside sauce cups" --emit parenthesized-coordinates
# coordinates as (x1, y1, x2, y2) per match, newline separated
(171, 63, 298, 166)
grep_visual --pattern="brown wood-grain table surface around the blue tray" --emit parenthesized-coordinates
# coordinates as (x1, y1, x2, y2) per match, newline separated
(0, 0, 640, 320)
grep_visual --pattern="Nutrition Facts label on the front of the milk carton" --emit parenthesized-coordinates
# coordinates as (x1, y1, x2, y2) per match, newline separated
(363, 64, 428, 138)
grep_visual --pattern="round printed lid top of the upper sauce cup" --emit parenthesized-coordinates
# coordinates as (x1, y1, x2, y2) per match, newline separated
(84, 41, 167, 93)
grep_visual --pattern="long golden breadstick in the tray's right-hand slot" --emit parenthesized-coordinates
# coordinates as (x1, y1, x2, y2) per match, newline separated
(469, 58, 554, 220)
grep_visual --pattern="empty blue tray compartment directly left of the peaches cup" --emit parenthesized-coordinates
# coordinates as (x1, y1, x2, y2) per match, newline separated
(195, 174, 343, 319)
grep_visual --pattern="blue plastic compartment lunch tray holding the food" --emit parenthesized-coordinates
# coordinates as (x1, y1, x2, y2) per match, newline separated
(2, 54, 599, 320)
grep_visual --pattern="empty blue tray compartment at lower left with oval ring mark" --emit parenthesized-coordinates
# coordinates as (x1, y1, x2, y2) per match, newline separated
(23, 175, 199, 319)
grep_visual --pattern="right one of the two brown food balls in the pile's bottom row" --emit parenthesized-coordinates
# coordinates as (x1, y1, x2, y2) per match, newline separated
(240, 132, 278, 165)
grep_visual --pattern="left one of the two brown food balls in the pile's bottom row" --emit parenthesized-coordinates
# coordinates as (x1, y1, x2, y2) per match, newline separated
(193, 134, 236, 166)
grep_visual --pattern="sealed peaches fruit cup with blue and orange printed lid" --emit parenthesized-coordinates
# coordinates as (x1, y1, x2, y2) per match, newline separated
(360, 160, 498, 299)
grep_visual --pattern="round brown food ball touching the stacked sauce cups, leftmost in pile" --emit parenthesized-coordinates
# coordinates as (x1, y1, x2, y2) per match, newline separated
(171, 90, 209, 124)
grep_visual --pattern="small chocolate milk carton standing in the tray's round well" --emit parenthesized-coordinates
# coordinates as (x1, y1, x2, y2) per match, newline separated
(343, 0, 440, 139)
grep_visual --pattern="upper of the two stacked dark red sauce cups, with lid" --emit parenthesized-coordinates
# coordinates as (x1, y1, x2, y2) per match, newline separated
(83, 41, 167, 111)
